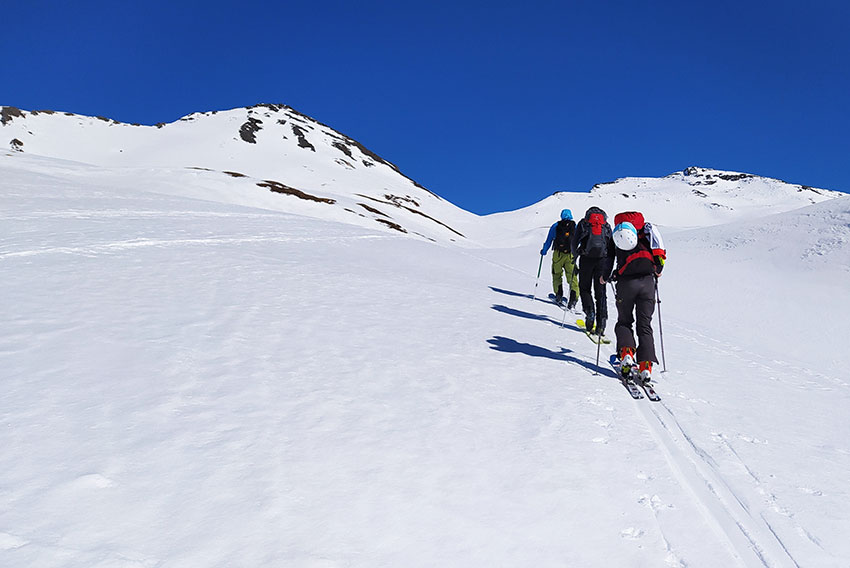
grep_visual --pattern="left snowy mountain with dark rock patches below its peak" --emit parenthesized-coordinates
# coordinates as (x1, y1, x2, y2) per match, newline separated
(0, 104, 475, 242)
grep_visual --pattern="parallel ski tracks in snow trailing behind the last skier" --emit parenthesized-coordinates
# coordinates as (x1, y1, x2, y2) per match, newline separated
(637, 401, 800, 568)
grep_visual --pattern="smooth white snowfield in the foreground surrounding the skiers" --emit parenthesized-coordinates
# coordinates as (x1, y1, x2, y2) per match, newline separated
(0, 108, 850, 567)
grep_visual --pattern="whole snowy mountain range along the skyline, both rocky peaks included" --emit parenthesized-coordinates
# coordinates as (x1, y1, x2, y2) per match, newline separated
(0, 104, 842, 248)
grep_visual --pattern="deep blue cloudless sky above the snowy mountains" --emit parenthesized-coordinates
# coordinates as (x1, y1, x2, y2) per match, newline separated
(6, 0, 850, 213)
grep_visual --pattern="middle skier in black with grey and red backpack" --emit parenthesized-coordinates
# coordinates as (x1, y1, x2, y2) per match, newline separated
(570, 207, 614, 336)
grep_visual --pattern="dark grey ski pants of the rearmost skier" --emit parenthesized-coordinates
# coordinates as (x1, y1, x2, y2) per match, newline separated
(614, 274, 658, 363)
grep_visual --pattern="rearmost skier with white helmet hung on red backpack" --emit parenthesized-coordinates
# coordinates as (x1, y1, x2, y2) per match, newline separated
(611, 211, 667, 383)
